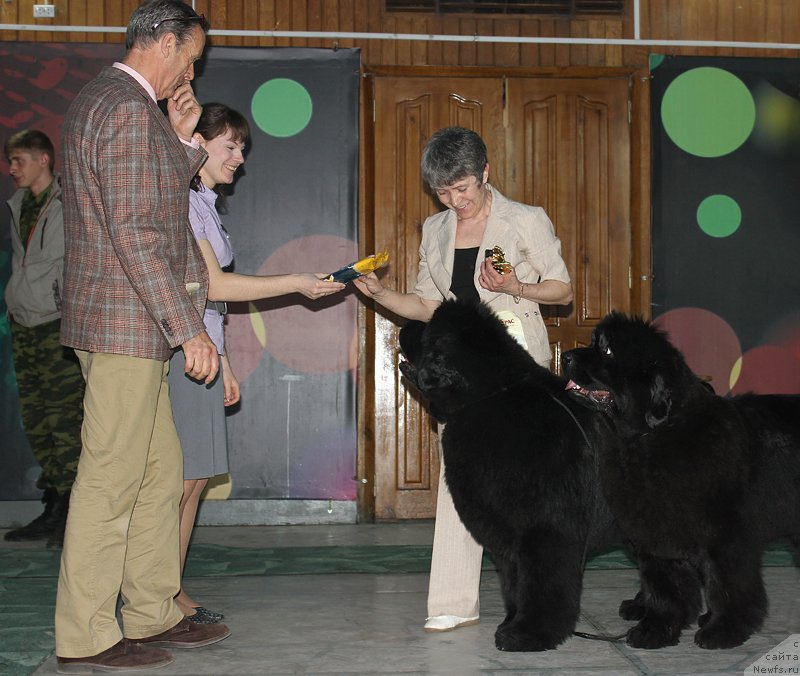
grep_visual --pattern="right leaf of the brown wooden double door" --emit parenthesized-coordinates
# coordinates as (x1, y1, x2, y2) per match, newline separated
(506, 78, 630, 370)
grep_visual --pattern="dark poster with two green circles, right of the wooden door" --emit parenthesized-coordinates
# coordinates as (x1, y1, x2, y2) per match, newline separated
(650, 55, 800, 395)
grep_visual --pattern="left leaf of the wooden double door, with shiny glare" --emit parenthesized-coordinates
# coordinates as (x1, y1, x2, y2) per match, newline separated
(374, 77, 503, 519)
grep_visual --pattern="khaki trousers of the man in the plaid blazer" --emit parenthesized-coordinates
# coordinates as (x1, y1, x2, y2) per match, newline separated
(55, 350, 183, 657)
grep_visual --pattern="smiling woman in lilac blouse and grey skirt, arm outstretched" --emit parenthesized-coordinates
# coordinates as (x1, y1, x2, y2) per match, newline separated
(169, 103, 345, 624)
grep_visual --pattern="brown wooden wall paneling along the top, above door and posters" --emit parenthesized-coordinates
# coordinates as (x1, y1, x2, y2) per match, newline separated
(0, 0, 800, 68)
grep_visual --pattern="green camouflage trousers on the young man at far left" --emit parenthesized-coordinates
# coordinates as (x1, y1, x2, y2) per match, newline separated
(11, 319, 84, 495)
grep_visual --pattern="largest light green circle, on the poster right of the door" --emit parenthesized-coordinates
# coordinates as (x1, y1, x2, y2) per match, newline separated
(661, 67, 756, 157)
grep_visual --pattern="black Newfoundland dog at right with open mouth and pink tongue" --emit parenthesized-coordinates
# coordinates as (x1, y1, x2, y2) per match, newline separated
(562, 313, 800, 648)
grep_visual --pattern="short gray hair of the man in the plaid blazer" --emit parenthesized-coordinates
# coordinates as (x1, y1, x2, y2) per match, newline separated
(125, 0, 208, 50)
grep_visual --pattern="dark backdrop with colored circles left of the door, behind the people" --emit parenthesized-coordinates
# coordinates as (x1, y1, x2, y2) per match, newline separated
(0, 43, 360, 500)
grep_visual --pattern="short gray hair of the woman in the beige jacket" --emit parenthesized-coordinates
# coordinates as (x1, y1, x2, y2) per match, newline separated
(421, 127, 489, 188)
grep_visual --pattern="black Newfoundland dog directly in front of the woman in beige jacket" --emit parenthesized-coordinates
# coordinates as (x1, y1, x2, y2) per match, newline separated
(400, 301, 620, 651)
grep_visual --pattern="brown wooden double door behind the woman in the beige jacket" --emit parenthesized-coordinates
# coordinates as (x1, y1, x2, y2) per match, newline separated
(365, 76, 631, 520)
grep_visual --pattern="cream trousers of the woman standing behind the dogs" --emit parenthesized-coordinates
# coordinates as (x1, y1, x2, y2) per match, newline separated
(428, 434, 483, 617)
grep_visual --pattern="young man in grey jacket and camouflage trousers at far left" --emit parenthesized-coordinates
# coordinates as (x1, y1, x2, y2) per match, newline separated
(5, 129, 84, 547)
